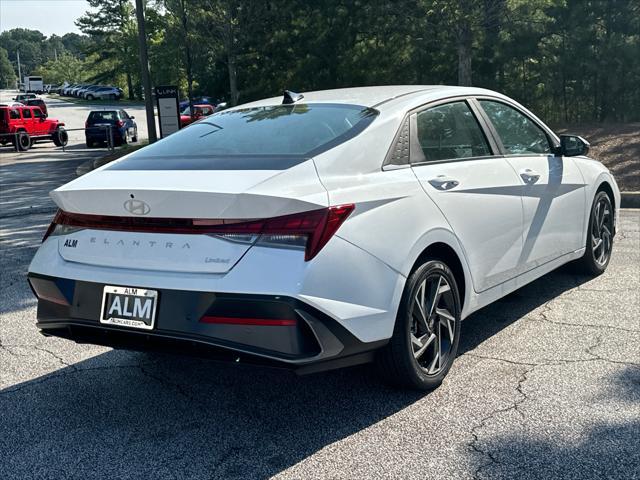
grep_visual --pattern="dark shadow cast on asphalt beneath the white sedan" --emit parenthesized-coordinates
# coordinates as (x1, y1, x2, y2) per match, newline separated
(0, 264, 600, 479)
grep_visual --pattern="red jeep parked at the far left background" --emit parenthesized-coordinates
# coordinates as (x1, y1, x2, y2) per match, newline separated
(0, 105, 69, 152)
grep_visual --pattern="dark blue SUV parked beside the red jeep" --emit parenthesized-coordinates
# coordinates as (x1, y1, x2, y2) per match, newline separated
(84, 110, 138, 148)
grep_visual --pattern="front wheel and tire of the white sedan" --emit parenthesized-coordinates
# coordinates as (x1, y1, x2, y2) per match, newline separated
(578, 191, 614, 276)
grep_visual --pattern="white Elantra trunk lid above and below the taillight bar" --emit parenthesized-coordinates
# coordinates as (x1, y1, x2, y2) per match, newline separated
(51, 160, 327, 273)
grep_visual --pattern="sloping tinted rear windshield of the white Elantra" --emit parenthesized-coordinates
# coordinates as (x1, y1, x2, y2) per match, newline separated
(110, 103, 378, 170)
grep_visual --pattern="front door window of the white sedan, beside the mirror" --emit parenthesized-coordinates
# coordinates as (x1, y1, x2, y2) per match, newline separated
(480, 100, 552, 155)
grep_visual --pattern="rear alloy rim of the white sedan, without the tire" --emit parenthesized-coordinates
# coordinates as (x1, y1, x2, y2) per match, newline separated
(410, 273, 458, 375)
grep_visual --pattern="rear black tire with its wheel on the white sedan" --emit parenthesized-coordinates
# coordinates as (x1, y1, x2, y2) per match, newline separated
(376, 260, 461, 391)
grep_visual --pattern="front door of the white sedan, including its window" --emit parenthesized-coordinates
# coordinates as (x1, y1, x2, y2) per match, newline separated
(477, 98, 585, 271)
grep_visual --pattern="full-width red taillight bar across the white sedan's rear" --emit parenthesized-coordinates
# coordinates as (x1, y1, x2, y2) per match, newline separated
(42, 204, 355, 261)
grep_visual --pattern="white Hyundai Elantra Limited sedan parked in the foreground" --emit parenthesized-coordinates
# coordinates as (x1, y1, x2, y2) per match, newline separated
(29, 86, 620, 389)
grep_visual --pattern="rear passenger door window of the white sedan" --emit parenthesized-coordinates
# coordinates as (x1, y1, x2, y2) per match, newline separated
(416, 102, 491, 162)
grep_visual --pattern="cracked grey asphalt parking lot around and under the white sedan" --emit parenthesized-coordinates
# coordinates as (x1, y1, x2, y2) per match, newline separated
(0, 146, 640, 479)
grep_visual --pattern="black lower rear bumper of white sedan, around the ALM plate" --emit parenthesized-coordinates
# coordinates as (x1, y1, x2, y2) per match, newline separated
(28, 273, 386, 373)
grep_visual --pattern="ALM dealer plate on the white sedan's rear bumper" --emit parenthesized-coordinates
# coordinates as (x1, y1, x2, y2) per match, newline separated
(100, 285, 158, 330)
